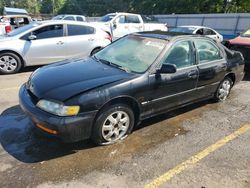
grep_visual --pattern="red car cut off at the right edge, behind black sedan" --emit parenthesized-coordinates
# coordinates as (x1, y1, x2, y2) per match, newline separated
(227, 29, 250, 71)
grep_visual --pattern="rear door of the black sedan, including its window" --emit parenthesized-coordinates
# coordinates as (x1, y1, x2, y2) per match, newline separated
(194, 39, 227, 97)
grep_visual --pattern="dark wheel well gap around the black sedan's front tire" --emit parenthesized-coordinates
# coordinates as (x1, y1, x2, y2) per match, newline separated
(96, 97, 140, 125)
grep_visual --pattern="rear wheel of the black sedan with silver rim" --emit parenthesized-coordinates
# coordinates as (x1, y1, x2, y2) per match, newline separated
(214, 77, 233, 102)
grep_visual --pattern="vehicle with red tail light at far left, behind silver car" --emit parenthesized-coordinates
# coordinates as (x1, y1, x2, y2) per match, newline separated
(0, 15, 32, 35)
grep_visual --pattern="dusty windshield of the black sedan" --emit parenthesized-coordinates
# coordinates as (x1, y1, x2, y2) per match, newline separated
(95, 35, 167, 73)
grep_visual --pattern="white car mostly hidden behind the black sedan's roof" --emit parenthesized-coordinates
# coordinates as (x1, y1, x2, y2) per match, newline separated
(171, 25, 223, 42)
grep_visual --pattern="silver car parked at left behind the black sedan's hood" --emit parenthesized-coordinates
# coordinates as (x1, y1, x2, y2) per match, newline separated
(0, 21, 111, 74)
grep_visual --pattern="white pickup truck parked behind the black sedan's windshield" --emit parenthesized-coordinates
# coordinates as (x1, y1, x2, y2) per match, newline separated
(95, 12, 168, 40)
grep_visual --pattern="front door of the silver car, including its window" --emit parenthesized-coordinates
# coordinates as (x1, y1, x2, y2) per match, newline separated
(23, 24, 67, 65)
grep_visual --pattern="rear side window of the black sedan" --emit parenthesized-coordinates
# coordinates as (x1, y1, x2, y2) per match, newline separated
(195, 39, 222, 64)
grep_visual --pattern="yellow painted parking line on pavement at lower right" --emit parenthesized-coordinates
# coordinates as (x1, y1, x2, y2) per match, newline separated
(144, 124, 250, 188)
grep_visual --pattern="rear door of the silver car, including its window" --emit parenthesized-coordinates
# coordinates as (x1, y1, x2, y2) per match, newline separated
(66, 24, 97, 58)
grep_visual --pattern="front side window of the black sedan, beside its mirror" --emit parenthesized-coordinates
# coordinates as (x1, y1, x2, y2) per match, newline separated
(163, 41, 195, 68)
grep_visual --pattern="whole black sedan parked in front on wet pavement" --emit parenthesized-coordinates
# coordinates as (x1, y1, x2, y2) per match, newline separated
(19, 32, 244, 144)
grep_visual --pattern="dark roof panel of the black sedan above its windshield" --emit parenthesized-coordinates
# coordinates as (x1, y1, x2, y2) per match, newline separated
(133, 31, 196, 40)
